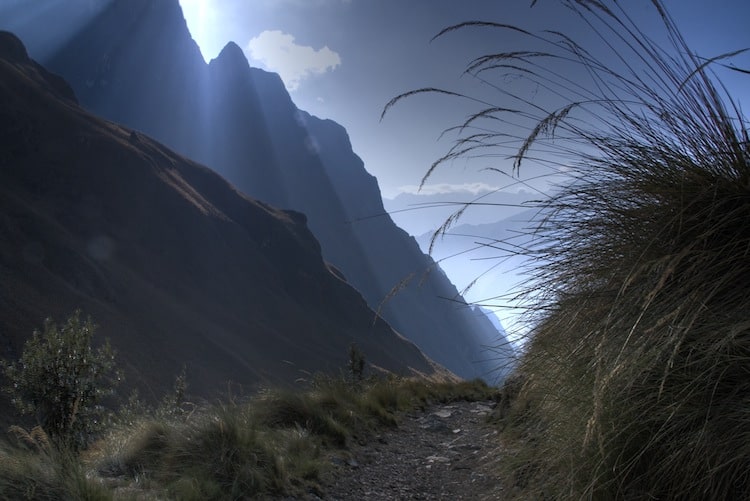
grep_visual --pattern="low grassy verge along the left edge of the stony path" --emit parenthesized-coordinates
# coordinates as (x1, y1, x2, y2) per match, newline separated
(0, 378, 495, 500)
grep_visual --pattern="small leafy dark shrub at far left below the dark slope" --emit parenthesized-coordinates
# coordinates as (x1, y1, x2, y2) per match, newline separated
(0, 311, 120, 447)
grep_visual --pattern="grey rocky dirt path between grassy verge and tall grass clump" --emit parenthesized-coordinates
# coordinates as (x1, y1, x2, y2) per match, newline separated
(322, 402, 507, 501)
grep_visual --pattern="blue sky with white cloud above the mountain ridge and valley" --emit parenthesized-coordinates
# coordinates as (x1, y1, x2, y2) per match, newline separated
(180, 0, 750, 336)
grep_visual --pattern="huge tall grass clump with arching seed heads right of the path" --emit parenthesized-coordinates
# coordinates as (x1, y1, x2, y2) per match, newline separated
(386, 0, 750, 500)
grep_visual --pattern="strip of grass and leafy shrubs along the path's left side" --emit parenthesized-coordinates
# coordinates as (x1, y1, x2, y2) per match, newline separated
(0, 313, 495, 500)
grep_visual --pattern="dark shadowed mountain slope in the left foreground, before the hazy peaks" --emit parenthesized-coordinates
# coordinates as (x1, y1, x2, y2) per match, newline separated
(0, 32, 444, 396)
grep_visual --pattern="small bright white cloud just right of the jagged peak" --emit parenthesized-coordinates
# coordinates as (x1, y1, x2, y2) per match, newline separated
(247, 30, 341, 91)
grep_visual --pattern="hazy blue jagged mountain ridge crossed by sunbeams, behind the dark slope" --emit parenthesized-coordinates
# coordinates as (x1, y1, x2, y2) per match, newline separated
(2, 0, 510, 377)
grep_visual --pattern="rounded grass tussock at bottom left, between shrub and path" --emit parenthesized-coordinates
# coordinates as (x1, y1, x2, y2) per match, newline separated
(108, 405, 287, 499)
